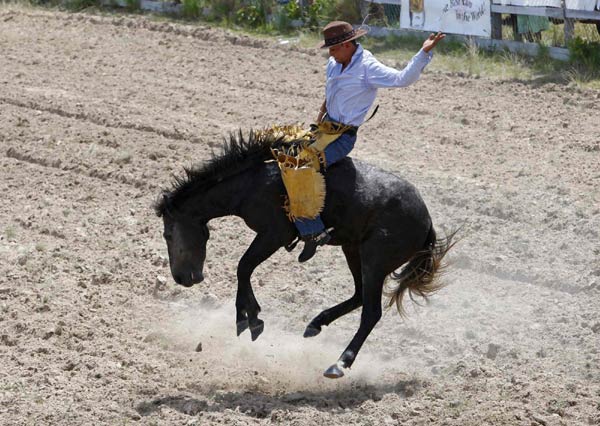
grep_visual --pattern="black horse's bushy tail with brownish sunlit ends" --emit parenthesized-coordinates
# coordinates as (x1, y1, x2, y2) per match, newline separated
(384, 225, 458, 316)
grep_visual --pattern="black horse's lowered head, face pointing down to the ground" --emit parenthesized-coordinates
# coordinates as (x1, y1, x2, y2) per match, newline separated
(162, 201, 209, 287)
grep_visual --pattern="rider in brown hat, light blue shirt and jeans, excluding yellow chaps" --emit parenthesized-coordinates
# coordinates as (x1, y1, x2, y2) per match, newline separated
(294, 21, 445, 262)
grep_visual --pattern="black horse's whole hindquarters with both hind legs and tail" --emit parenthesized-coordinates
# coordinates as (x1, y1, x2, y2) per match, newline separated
(305, 158, 453, 378)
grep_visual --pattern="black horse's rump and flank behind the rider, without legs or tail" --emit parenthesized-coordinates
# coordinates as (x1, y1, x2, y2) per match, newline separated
(323, 158, 432, 262)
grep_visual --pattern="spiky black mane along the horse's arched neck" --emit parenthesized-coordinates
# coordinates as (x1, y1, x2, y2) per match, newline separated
(154, 130, 281, 216)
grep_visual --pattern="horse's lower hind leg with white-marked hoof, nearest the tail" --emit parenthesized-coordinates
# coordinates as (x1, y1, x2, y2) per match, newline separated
(324, 255, 387, 379)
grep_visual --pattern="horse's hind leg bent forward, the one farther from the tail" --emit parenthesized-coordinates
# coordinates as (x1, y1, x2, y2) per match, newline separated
(304, 246, 362, 337)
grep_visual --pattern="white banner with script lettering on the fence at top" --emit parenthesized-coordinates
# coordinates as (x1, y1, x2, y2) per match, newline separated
(400, 0, 492, 37)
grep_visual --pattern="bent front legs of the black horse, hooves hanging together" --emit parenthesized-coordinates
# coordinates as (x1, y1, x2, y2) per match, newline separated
(235, 233, 282, 341)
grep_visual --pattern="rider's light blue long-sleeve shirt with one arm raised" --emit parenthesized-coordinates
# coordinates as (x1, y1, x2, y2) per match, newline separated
(325, 44, 433, 126)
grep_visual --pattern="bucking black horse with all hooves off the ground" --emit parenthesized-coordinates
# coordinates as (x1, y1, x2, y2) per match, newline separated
(155, 132, 453, 378)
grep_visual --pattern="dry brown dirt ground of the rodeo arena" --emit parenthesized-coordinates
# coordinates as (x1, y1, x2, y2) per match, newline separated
(0, 6, 600, 425)
